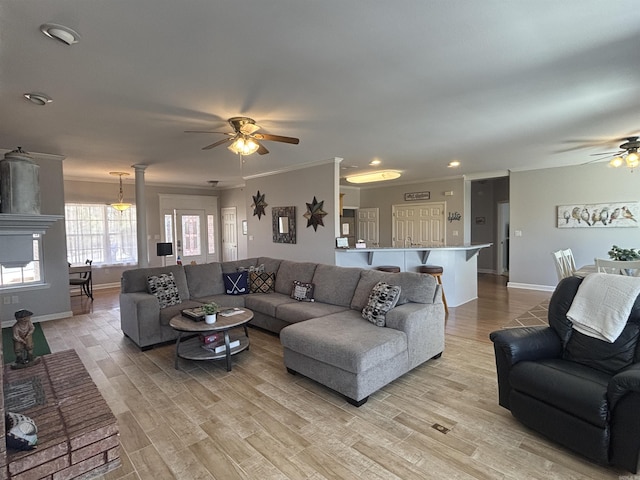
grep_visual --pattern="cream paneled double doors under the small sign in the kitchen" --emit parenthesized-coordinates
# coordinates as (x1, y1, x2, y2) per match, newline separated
(391, 202, 446, 248)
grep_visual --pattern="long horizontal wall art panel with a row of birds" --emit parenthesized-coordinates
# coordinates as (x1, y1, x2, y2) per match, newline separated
(558, 202, 640, 228)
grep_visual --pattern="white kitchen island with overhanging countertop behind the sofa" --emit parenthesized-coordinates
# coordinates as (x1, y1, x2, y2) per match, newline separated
(336, 243, 491, 307)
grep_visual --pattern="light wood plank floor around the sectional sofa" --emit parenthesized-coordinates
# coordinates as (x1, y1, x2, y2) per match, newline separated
(43, 275, 632, 480)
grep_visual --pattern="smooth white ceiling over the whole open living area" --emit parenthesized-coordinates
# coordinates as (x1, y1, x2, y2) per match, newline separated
(0, 0, 640, 186)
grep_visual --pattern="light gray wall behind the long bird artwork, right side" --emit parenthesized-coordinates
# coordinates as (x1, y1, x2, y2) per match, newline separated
(509, 163, 640, 288)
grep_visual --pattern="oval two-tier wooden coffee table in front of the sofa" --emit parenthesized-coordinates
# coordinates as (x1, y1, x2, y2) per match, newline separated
(169, 308, 253, 372)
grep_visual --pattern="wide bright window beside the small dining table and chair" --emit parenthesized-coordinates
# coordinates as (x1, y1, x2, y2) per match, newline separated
(64, 203, 138, 265)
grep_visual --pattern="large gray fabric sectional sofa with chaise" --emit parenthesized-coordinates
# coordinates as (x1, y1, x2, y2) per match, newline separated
(120, 257, 445, 406)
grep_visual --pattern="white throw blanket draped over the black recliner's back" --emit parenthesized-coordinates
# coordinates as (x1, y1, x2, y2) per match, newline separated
(567, 273, 640, 343)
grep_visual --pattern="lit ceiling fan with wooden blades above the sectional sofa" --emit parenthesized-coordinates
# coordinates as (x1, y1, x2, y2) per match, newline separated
(185, 117, 300, 155)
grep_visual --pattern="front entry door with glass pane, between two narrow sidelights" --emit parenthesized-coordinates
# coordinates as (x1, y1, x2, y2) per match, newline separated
(176, 210, 207, 265)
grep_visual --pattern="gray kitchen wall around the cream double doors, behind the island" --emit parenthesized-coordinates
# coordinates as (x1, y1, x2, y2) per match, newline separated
(360, 178, 465, 247)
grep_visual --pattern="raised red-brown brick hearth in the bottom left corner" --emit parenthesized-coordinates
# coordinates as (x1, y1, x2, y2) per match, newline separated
(0, 350, 120, 480)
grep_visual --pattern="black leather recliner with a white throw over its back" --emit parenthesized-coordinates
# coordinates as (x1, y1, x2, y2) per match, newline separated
(490, 277, 640, 473)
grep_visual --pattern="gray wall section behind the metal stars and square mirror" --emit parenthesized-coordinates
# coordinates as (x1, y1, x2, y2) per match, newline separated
(245, 161, 339, 264)
